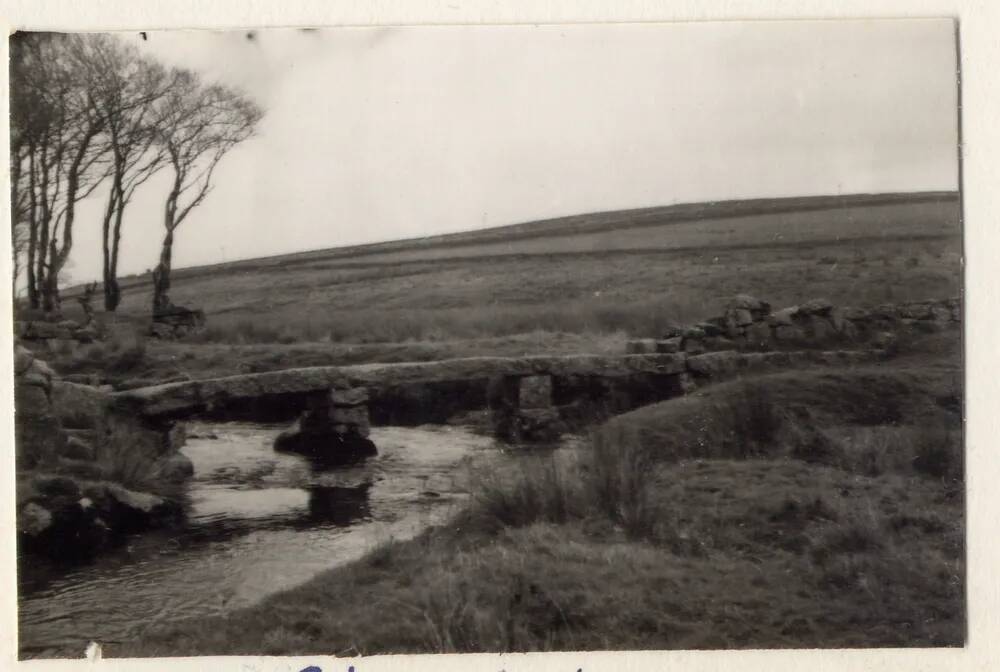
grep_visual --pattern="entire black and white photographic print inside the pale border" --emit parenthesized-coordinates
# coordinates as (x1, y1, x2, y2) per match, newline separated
(4, 17, 968, 670)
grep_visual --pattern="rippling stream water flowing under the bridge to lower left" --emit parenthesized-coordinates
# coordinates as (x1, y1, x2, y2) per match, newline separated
(19, 423, 493, 657)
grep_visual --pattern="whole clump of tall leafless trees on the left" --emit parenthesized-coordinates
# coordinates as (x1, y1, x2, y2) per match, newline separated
(10, 33, 261, 316)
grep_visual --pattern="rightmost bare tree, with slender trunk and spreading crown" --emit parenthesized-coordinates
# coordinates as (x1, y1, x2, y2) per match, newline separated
(153, 70, 262, 318)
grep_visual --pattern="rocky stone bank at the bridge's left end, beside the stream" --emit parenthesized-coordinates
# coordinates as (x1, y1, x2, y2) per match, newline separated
(14, 344, 193, 561)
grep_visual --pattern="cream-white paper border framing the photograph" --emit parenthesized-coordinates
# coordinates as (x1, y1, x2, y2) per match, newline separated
(0, 0, 1000, 672)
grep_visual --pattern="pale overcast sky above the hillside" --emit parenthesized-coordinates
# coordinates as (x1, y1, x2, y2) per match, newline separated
(69, 20, 957, 282)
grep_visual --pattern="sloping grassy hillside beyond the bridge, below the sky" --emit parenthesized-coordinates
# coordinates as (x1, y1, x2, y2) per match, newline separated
(47, 193, 962, 386)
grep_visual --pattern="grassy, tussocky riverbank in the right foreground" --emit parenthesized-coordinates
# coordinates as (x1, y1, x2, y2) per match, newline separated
(105, 334, 965, 656)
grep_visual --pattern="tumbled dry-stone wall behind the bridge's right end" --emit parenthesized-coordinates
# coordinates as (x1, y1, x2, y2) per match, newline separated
(626, 294, 962, 355)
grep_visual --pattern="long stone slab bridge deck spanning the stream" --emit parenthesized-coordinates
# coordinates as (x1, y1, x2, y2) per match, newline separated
(110, 350, 881, 440)
